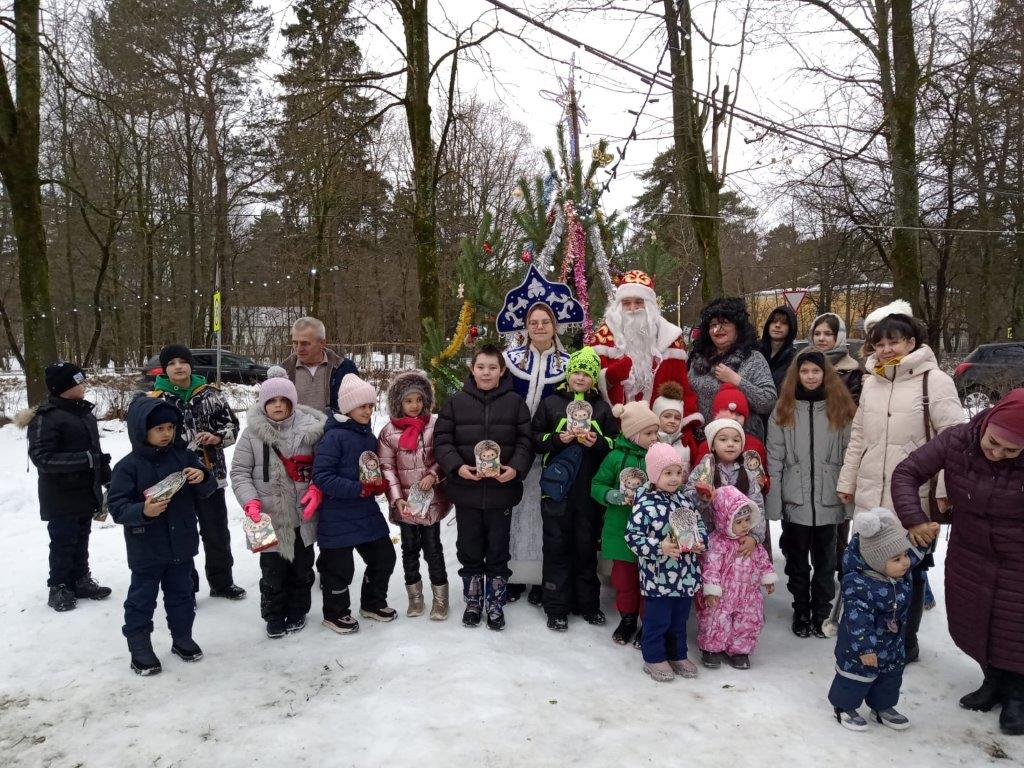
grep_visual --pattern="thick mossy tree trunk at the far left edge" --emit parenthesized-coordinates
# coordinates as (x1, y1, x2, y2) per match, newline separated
(0, 0, 57, 402)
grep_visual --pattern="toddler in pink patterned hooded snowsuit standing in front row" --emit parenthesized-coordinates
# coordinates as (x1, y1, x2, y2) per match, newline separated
(697, 485, 778, 670)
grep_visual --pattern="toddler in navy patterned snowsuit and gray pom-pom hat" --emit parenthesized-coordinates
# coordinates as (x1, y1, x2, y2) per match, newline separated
(828, 507, 921, 731)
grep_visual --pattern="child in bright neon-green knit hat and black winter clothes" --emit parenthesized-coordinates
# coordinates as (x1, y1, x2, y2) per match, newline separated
(534, 347, 618, 632)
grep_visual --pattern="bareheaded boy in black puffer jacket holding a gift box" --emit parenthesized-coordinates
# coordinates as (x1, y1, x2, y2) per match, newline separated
(434, 342, 534, 630)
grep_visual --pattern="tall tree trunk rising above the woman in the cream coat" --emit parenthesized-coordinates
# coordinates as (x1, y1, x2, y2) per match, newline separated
(879, 0, 922, 316)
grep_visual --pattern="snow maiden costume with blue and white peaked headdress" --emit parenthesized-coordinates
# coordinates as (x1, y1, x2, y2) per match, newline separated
(497, 264, 584, 584)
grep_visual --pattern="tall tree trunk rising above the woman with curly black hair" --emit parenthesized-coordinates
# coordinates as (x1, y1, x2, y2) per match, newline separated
(663, 0, 724, 301)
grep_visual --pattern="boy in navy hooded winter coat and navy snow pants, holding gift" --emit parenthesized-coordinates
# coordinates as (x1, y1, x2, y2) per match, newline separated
(106, 396, 217, 675)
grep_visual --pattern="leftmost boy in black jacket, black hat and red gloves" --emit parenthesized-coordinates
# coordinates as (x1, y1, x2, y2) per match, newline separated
(15, 362, 111, 612)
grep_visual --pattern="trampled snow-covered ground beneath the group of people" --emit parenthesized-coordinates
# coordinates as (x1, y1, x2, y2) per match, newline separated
(0, 415, 1024, 768)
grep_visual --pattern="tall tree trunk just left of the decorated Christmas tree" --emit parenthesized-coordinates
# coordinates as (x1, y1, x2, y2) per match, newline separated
(401, 0, 440, 339)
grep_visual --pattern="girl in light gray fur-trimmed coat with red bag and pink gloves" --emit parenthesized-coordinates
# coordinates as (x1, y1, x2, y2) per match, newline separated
(231, 369, 325, 638)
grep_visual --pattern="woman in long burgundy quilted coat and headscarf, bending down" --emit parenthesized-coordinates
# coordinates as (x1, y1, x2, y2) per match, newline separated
(892, 388, 1024, 735)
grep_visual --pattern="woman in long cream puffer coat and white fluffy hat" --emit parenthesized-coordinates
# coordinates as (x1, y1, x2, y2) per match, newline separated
(837, 314, 964, 662)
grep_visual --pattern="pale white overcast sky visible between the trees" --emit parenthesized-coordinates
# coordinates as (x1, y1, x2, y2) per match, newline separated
(270, 0, 855, 227)
